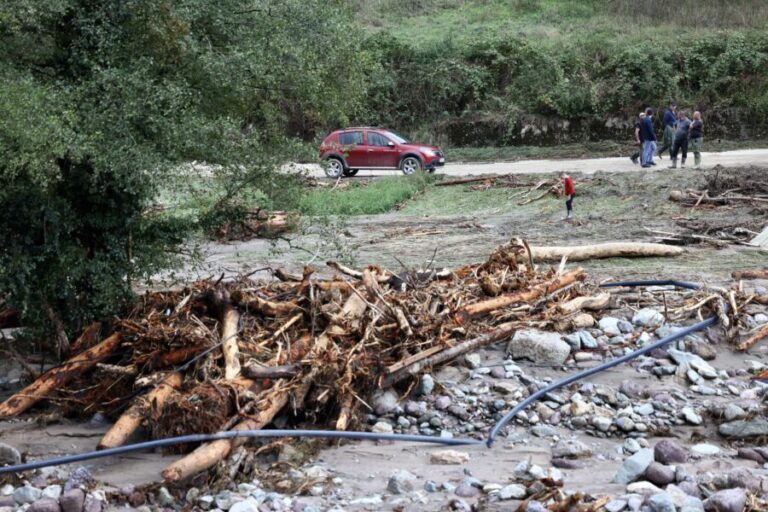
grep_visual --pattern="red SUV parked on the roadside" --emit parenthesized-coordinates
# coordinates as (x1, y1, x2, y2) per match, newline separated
(320, 128, 445, 178)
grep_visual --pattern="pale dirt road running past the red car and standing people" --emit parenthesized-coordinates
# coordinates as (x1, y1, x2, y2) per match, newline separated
(304, 149, 768, 178)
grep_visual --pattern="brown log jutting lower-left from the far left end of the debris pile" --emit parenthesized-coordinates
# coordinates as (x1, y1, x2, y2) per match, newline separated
(0, 333, 120, 418)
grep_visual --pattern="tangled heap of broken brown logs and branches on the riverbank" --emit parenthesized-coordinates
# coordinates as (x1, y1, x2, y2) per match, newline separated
(0, 243, 760, 481)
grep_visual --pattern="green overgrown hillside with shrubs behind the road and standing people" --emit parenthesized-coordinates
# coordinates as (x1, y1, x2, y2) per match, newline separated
(355, 0, 768, 146)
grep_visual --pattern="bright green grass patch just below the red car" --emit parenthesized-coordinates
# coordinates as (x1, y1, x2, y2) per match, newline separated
(299, 172, 435, 215)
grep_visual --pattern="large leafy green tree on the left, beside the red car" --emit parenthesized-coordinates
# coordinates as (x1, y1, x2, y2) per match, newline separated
(0, 0, 366, 348)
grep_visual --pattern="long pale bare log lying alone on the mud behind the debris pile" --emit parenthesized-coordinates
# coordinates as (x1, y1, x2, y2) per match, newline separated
(521, 242, 685, 261)
